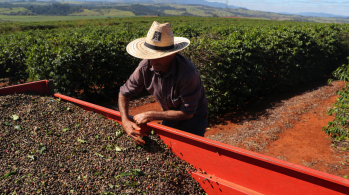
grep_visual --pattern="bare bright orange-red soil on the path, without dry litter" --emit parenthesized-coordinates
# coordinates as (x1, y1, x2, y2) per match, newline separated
(261, 96, 349, 176)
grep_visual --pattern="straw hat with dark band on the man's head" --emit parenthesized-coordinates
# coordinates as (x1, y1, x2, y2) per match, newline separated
(126, 21, 190, 60)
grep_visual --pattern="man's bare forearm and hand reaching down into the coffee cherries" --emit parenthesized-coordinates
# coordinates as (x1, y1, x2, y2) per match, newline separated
(118, 93, 146, 145)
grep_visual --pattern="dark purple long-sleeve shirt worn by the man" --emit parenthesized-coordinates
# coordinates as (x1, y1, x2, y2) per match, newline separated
(120, 54, 208, 116)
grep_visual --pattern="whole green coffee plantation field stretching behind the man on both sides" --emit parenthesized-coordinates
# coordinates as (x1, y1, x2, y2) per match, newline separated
(0, 15, 348, 113)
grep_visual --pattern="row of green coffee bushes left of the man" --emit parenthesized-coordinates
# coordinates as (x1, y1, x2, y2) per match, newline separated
(0, 23, 212, 99)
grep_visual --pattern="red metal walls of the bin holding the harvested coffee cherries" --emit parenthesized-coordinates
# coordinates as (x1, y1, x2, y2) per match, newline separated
(0, 80, 349, 195)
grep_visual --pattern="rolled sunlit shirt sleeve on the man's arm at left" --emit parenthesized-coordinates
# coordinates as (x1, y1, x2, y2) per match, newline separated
(120, 66, 144, 98)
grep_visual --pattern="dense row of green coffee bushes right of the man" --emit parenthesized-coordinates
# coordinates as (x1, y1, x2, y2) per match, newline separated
(185, 24, 348, 112)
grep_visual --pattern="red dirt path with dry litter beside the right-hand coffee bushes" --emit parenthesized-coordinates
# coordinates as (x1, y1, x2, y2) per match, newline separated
(205, 82, 349, 177)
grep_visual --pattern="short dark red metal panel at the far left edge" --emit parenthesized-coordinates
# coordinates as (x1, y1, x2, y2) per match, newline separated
(0, 80, 49, 95)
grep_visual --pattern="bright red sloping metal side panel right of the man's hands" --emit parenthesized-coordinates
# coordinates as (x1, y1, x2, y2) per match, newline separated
(153, 123, 349, 195)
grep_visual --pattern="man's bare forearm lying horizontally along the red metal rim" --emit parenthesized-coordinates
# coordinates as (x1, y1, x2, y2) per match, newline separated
(133, 110, 193, 124)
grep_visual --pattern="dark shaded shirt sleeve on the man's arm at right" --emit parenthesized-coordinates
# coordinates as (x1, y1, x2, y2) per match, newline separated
(180, 74, 201, 114)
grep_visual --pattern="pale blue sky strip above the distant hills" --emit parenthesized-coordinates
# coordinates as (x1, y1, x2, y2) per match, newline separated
(207, 0, 349, 16)
